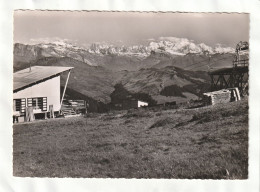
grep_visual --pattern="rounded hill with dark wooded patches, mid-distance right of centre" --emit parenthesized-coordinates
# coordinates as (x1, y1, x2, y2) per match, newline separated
(117, 66, 210, 103)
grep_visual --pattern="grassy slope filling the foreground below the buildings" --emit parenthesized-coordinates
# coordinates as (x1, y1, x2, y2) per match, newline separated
(13, 100, 248, 179)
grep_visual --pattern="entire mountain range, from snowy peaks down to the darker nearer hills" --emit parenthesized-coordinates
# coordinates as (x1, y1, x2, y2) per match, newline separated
(14, 37, 234, 110)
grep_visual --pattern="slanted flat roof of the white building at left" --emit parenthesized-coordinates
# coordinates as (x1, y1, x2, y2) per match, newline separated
(13, 66, 73, 92)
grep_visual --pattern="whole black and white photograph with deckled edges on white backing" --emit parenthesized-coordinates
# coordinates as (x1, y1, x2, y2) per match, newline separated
(12, 10, 250, 180)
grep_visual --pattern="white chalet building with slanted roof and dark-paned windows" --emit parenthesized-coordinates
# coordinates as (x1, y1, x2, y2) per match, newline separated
(13, 66, 73, 122)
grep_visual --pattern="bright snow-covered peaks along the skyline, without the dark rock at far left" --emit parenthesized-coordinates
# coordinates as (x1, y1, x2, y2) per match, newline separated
(17, 37, 235, 61)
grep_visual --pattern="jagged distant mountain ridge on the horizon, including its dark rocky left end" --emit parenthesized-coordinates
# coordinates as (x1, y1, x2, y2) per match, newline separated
(14, 37, 235, 65)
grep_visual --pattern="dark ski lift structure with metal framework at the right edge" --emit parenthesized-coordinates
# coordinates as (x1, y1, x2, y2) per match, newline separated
(209, 41, 249, 96)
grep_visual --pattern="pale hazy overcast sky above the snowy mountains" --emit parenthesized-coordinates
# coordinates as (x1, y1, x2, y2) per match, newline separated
(14, 11, 249, 47)
